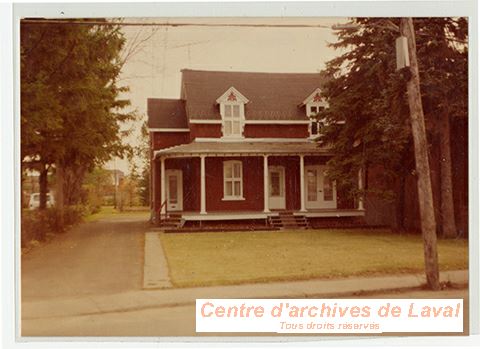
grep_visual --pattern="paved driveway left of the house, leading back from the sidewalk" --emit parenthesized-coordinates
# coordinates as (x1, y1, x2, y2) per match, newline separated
(21, 216, 148, 301)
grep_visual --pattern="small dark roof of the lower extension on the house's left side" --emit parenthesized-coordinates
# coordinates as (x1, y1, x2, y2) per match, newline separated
(147, 98, 188, 128)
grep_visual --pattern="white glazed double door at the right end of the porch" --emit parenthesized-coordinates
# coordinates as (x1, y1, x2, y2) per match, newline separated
(305, 165, 337, 209)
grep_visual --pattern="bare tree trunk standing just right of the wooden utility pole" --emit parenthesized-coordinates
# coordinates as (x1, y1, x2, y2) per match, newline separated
(440, 113, 457, 238)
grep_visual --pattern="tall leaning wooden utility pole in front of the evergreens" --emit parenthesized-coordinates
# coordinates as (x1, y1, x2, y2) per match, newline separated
(400, 17, 440, 290)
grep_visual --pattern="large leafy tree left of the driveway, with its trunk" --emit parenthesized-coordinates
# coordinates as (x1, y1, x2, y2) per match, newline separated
(21, 21, 133, 223)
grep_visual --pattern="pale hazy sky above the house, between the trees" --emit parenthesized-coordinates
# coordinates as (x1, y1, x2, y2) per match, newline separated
(106, 17, 348, 173)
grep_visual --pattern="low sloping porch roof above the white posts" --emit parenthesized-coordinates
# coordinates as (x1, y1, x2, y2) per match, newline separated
(154, 141, 332, 158)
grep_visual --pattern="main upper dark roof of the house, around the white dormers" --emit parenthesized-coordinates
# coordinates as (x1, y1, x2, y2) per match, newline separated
(182, 69, 325, 120)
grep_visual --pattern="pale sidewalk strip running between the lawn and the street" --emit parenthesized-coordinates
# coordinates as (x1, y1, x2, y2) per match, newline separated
(21, 270, 468, 320)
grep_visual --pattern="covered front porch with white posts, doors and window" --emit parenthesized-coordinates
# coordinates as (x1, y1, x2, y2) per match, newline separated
(152, 142, 365, 222)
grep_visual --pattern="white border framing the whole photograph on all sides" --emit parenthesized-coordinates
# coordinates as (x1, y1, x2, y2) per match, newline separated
(0, 0, 480, 348)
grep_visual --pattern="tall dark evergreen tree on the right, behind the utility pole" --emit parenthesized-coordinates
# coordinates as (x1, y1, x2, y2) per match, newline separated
(318, 18, 468, 235)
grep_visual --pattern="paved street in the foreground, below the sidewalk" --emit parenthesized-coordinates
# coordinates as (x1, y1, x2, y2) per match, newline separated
(22, 289, 468, 337)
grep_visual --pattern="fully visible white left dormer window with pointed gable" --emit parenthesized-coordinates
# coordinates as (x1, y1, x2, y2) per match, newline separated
(217, 87, 248, 138)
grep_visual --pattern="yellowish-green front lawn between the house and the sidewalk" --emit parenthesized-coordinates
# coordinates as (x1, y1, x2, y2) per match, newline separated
(161, 229, 468, 287)
